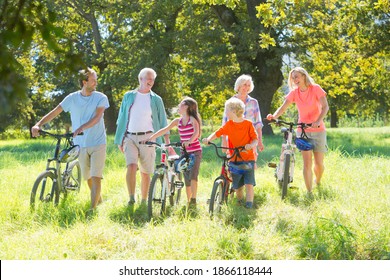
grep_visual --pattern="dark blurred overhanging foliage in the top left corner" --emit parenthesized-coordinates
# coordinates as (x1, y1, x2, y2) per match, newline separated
(0, 0, 80, 126)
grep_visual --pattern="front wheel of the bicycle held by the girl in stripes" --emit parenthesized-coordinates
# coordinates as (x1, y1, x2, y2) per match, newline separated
(148, 174, 168, 220)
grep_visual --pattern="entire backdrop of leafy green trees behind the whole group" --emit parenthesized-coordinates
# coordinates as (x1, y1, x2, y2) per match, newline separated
(0, 0, 390, 132)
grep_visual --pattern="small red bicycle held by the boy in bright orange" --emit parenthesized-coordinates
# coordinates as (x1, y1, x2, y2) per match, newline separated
(208, 142, 245, 216)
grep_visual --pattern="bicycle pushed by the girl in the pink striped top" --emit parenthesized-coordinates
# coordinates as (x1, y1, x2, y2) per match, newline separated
(140, 141, 194, 220)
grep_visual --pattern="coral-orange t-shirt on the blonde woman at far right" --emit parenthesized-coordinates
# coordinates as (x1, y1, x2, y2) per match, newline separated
(286, 85, 326, 132)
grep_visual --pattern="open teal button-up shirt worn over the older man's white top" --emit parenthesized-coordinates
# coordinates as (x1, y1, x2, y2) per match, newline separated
(114, 90, 168, 145)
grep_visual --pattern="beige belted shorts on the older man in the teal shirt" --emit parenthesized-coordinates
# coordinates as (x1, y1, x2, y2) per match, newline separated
(123, 134, 156, 174)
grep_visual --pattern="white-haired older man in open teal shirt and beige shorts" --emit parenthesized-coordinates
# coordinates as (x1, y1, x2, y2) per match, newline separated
(114, 68, 169, 205)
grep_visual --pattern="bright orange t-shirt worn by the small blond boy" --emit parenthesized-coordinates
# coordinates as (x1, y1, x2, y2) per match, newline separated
(215, 119, 258, 161)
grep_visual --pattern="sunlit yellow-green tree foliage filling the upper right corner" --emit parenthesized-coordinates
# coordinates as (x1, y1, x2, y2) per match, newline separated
(258, 0, 390, 127)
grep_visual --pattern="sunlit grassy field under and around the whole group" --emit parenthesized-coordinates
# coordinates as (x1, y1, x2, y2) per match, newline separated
(0, 127, 390, 260)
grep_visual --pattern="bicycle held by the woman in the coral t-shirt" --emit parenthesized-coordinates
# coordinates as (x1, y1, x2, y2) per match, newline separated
(267, 119, 311, 199)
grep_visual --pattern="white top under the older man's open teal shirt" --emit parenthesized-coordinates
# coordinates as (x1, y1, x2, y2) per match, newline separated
(127, 92, 153, 132)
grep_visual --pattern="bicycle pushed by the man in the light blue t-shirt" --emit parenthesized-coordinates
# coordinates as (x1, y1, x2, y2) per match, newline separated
(30, 130, 81, 208)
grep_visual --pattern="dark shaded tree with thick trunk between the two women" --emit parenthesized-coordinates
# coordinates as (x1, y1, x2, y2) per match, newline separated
(203, 0, 285, 134)
